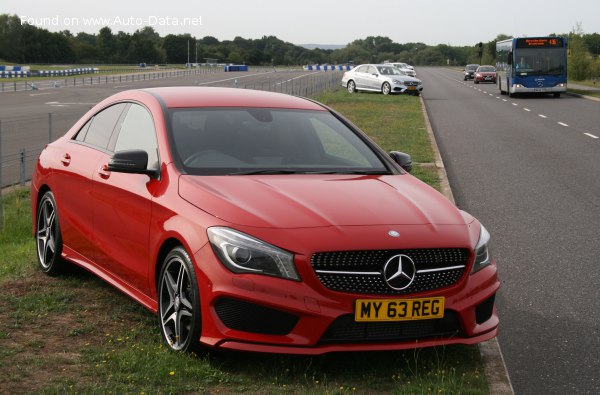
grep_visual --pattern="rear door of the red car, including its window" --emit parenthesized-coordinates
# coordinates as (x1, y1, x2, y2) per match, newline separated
(52, 105, 125, 260)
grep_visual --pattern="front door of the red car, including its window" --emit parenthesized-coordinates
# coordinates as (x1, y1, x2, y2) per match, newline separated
(92, 103, 159, 294)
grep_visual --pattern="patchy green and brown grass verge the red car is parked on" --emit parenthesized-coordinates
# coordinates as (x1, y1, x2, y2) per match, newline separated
(0, 91, 488, 394)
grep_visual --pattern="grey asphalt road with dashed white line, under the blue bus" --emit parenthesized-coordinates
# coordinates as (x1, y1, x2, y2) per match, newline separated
(417, 68, 600, 394)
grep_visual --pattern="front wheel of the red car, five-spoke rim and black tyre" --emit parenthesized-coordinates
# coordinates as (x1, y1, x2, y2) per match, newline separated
(158, 247, 202, 352)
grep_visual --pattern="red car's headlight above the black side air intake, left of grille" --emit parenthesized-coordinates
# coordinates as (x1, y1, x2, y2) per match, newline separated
(207, 227, 300, 281)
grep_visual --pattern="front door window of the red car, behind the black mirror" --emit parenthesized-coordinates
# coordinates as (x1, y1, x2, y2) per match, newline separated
(114, 104, 158, 169)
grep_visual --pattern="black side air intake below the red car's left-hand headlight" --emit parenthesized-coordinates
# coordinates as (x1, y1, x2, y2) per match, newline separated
(215, 298, 300, 335)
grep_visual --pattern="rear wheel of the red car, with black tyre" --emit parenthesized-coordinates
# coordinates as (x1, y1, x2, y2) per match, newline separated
(35, 191, 66, 276)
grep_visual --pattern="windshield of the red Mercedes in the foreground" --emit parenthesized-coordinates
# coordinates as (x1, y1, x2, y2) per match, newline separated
(171, 108, 389, 175)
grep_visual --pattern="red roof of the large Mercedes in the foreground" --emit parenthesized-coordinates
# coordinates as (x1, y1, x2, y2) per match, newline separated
(141, 86, 326, 111)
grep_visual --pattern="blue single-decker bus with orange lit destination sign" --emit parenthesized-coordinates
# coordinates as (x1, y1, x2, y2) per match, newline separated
(496, 37, 567, 97)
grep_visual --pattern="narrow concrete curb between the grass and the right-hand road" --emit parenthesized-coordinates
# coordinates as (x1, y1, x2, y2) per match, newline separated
(419, 96, 515, 395)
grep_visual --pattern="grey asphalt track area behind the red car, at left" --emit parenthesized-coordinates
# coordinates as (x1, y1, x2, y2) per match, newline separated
(0, 68, 343, 186)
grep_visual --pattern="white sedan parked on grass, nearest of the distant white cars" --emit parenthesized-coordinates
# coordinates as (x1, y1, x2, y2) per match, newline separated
(342, 64, 423, 96)
